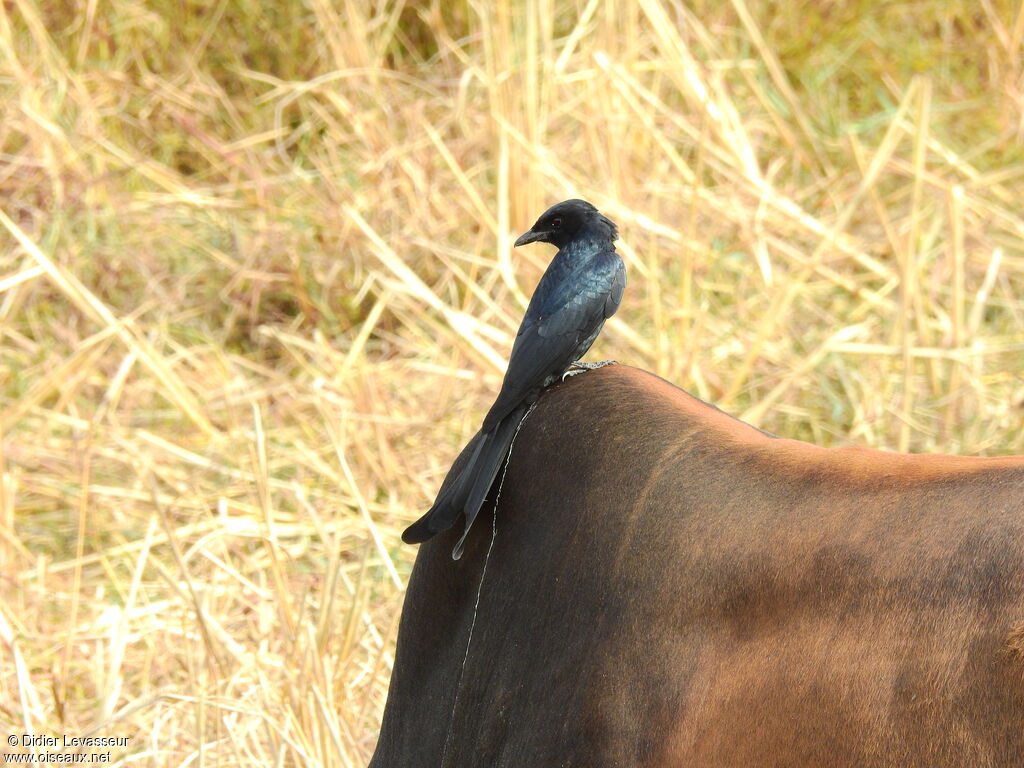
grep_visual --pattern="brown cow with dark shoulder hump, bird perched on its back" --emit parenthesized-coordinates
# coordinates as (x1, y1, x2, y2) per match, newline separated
(371, 366, 1024, 768)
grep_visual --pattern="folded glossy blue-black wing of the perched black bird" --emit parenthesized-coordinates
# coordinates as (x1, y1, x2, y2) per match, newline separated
(483, 249, 626, 430)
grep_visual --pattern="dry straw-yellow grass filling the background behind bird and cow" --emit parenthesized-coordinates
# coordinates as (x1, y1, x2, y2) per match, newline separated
(0, 0, 1024, 766)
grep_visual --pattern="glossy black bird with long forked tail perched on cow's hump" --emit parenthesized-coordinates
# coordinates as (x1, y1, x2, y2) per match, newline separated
(401, 200, 626, 559)
